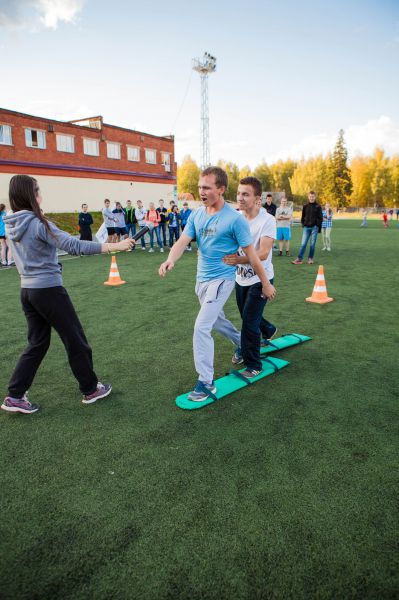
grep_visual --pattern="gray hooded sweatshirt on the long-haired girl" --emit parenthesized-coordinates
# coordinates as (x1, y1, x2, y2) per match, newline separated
(3, 210, 101, 289)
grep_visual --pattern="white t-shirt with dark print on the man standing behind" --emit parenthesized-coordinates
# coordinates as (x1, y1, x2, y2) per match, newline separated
(236, 208, 276, 285)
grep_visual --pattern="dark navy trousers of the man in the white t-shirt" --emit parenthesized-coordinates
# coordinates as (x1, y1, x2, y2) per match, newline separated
(236, 279, 276, 371)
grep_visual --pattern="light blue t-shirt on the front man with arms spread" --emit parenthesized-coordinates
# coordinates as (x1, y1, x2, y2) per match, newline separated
(184, 203, 252, 281)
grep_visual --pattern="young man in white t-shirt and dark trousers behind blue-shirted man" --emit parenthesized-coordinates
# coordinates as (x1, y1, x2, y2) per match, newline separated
(224, 177, 277, 379)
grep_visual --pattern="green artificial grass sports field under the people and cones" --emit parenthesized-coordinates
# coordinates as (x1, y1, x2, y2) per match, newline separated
(0, 221, 399, 600)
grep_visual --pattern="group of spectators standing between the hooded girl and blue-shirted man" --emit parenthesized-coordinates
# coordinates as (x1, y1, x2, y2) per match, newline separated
(79, 198, 191, 252)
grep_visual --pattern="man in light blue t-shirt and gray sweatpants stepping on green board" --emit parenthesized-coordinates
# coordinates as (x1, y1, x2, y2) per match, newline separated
(159, 167, 275, 402)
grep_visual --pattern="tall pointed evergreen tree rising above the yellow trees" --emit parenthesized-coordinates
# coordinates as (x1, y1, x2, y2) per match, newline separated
(325, 129, 353, 208)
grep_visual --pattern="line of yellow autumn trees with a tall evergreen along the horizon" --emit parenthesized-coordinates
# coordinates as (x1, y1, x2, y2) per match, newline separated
(177, 129, 399, 208)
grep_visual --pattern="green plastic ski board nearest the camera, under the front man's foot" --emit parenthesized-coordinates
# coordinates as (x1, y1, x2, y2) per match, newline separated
(176, 358, 290, 410)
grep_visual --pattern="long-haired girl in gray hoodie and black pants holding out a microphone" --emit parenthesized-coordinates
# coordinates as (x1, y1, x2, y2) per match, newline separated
(1, 175, 134, 414)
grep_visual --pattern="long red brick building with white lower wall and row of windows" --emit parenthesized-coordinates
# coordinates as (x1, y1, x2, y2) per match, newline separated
(0, 108, 176, 212)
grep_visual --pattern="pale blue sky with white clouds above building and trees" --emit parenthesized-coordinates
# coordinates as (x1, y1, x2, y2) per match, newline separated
(0, 0, 399, 168)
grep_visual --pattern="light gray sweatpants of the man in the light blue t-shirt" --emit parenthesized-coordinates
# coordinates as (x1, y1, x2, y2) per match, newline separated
(193, 279, 240, 383)
